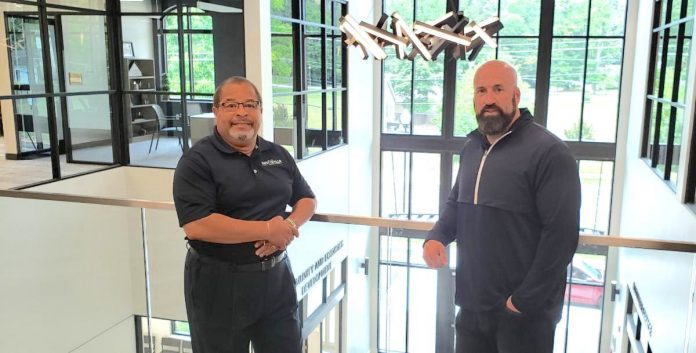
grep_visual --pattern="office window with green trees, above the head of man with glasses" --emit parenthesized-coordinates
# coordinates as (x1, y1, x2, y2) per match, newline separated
(162, 6, 215, 100)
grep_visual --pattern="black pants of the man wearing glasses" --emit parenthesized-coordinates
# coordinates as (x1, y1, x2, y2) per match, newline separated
(184, 251, 302, 353)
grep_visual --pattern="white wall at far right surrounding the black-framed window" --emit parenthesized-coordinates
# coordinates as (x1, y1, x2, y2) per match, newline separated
(611, 1, 696, 352)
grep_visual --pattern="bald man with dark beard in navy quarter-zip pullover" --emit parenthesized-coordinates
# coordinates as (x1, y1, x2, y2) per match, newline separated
(423, 60, 580, 353)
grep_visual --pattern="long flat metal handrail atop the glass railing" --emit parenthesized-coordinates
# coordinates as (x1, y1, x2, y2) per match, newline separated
(0, 190, 696, 254)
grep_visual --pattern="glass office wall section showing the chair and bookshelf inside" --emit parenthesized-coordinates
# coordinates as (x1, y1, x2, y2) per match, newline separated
(120, 0, 245, 168)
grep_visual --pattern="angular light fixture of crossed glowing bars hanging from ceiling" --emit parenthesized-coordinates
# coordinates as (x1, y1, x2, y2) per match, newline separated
(339, 11, 503, 61)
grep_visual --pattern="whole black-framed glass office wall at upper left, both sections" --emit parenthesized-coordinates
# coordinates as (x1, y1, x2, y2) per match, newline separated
(0, 0, 249, 186)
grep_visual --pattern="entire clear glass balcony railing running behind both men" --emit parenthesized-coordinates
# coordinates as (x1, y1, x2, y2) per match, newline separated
(0, 184, 696, 353)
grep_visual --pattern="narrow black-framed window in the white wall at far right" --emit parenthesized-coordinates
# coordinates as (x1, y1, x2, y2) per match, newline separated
(641, 0, 694, 187)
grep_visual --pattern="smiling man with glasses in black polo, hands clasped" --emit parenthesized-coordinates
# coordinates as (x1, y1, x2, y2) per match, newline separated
(174, 77, 316, 353)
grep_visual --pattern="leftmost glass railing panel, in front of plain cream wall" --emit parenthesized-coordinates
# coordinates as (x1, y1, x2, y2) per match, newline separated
(0, 197, 146, 352)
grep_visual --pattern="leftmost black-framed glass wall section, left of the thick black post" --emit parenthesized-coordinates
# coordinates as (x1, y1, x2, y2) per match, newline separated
(0, 1, 116, 187)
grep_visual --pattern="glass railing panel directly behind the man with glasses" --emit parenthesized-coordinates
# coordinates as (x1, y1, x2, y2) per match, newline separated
(136, 209, 354, 352)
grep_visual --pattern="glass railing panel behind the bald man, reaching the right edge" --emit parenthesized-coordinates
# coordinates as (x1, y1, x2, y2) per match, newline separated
(377, 228, 695, 353)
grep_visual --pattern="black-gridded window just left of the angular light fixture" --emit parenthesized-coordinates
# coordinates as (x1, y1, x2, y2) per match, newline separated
(271, 0, 346, 159)
